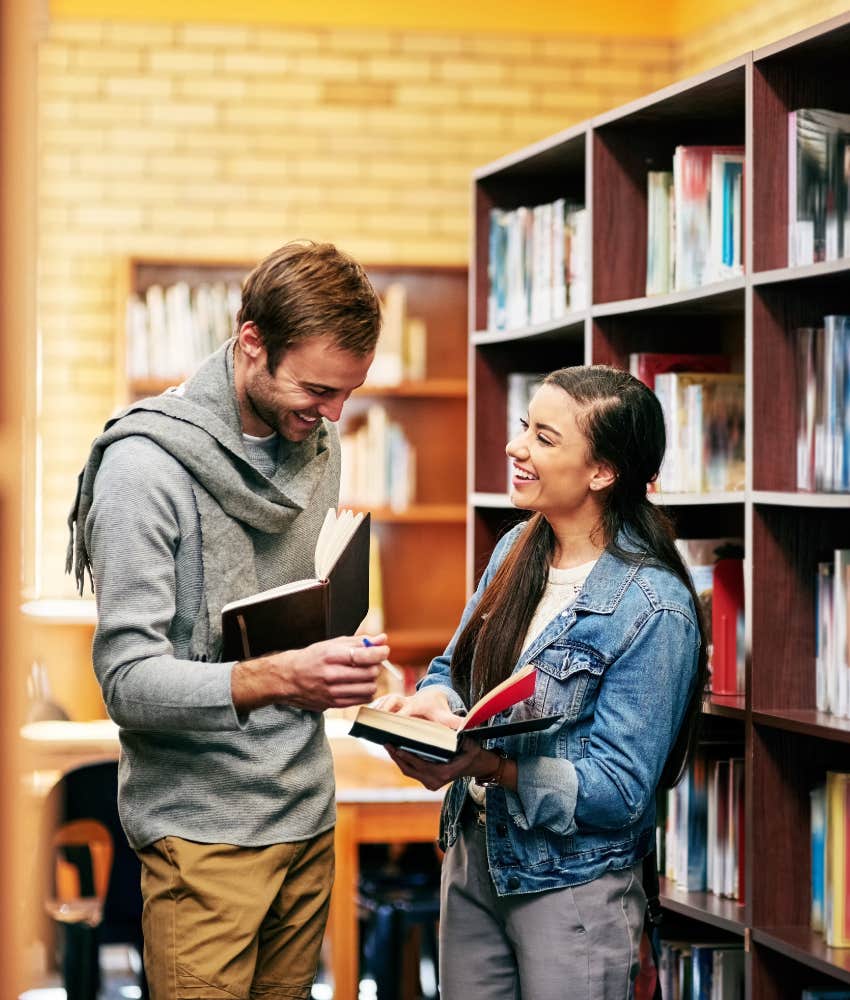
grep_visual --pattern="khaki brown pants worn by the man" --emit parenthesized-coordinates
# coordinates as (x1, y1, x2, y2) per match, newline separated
(138, 830, 334, 1000)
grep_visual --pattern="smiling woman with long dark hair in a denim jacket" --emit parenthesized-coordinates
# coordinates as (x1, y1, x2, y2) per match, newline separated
(381, 365, 706, 1000)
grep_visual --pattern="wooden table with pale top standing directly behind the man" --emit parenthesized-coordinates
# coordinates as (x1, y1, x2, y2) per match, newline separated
(23, 719, 443, 1000)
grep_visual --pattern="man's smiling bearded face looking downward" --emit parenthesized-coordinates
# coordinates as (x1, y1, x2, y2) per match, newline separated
(237, 335, 374, 441)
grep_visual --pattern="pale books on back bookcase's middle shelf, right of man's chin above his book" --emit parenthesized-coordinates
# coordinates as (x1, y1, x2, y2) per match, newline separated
(339, 403, 416, 511)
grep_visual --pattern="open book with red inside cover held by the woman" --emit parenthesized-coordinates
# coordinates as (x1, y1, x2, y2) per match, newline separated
(350, 664, 562, 763)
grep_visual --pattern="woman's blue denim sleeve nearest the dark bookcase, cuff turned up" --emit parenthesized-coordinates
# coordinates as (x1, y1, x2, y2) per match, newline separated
(507, 609, 699, 836)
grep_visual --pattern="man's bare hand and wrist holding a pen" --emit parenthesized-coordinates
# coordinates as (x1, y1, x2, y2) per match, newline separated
(230, 634, 390, 715)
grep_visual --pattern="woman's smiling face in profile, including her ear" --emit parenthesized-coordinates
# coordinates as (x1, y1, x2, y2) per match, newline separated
(505, 385, 611, 520)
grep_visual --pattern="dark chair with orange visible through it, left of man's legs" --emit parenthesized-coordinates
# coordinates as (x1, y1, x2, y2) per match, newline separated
(42, 761, 148, 1000)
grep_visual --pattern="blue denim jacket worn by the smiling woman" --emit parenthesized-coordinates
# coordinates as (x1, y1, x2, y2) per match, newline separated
(420, 525, 699, 895)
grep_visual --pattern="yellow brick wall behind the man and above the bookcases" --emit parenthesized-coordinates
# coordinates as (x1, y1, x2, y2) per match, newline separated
(27, 0, 844, 712)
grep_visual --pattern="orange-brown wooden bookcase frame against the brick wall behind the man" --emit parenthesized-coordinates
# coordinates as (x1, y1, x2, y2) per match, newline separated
(117, 257, 468, 667)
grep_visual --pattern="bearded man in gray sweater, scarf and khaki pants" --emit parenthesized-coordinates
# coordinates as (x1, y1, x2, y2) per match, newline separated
(69, 242, 389, 1000)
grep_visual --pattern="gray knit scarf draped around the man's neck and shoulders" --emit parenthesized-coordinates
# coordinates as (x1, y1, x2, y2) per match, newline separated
(65, 341, 340, 660)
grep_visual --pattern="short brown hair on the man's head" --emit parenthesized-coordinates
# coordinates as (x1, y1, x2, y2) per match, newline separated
(236, 240, 381, 374)
